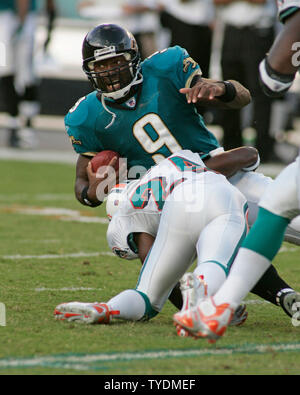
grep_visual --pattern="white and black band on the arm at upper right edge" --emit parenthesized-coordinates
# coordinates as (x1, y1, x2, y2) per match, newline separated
(259, 58, 295, 97)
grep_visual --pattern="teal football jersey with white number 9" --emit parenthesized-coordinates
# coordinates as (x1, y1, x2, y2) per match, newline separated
(65, 46, 219, 169)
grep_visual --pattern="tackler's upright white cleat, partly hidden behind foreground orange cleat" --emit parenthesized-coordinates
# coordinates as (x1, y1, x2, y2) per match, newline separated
(175, 273, 207, 337)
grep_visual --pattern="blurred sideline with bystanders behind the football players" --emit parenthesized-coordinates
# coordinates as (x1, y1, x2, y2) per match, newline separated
(0, 0, 300, 164)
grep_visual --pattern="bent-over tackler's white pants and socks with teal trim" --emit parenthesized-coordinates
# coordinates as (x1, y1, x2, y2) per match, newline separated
(107, 173, 247, 320)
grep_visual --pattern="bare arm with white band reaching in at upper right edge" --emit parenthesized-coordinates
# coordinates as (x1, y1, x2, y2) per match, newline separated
(259, 10, 300, 97)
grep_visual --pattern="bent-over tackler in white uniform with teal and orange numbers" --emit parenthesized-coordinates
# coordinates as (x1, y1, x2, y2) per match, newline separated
(55, 150, 247, 323)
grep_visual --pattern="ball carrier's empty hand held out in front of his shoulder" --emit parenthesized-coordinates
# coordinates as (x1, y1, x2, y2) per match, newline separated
(179, 78, 225, 104)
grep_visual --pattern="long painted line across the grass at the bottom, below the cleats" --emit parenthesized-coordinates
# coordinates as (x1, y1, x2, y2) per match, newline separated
(0, 343, 300, 370)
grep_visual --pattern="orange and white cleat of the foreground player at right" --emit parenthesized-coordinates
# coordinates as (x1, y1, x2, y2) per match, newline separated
(173, 297, 234, 343)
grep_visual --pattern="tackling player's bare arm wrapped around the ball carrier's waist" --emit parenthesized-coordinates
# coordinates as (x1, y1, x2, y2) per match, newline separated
(204, 147, 260, 177)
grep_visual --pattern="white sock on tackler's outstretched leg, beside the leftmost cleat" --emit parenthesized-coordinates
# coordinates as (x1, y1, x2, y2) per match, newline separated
(107, 289, 146, 321)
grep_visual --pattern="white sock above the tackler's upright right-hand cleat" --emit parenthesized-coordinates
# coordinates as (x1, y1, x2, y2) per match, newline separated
(194, 262, 226, 296)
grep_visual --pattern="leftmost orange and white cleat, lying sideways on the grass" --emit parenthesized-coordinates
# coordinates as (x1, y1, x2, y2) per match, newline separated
(54, 302, 116, 324)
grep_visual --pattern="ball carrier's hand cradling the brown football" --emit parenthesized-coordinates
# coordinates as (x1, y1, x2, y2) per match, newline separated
(87, 157, 127, 202)
